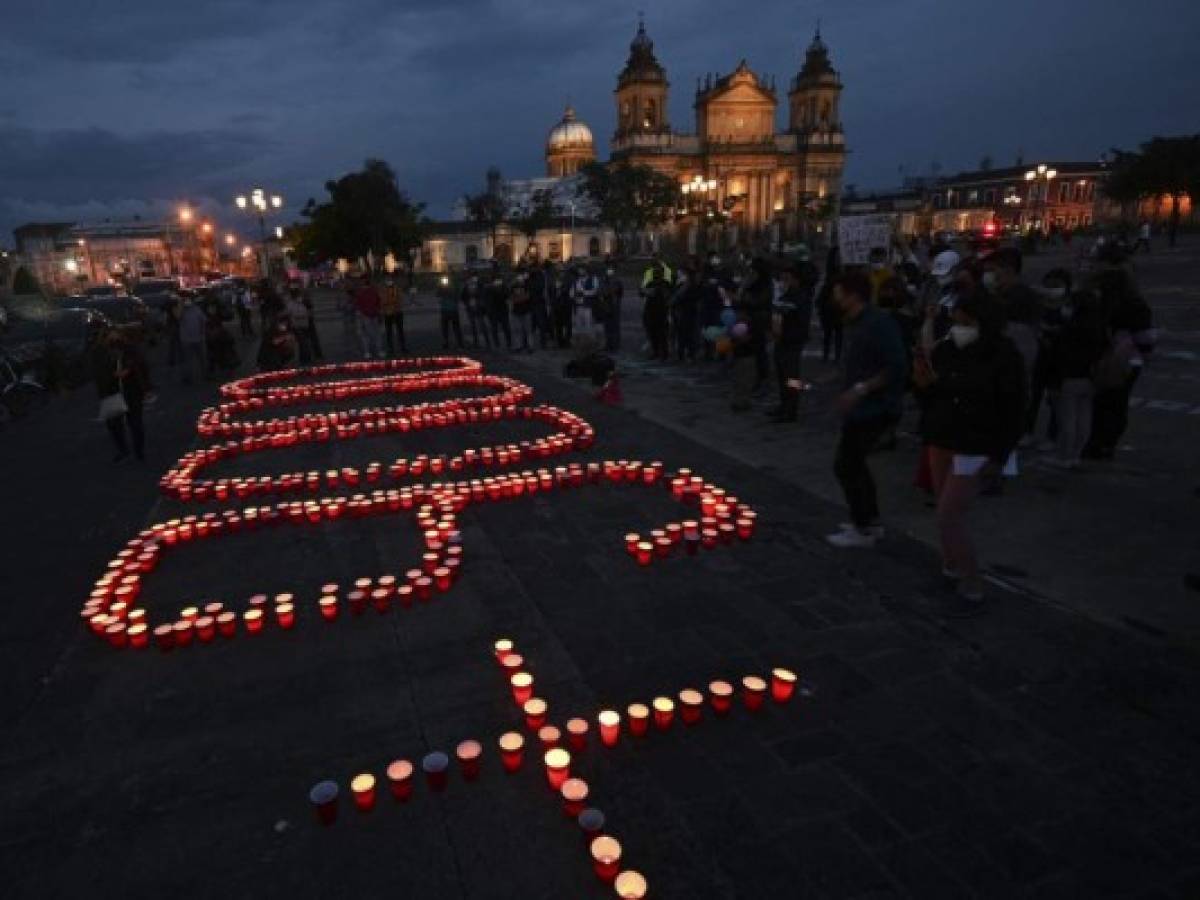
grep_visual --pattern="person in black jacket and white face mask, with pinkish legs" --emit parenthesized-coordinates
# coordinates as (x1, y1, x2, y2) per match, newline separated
(913, 286, 1026, 614)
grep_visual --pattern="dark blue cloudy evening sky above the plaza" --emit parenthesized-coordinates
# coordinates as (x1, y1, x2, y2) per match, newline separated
(0, 0, 1200, 245)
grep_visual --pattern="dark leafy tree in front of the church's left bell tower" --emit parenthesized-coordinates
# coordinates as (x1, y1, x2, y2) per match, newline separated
(576, 162, 679, 250)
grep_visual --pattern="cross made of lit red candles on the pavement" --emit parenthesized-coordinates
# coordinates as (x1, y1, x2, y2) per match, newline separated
(308, 637, 798, 900)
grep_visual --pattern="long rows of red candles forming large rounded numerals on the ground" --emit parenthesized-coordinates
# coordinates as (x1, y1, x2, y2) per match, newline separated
(80, 356, 758, 652)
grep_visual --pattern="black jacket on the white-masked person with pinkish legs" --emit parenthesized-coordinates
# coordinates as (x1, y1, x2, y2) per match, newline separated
(922, 337, 1027, 464)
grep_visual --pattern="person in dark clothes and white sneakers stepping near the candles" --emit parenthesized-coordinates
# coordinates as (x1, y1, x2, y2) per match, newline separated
(826, 271, 906, 547)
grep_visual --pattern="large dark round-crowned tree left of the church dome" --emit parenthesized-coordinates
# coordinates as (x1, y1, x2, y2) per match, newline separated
(288, 160, 428, 266)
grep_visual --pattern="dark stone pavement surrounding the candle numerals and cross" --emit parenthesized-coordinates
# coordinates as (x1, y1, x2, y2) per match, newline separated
(0, 297, 1200, 900)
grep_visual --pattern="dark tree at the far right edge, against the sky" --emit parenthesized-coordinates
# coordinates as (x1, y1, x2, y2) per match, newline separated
(1104, 134, 1200, 247)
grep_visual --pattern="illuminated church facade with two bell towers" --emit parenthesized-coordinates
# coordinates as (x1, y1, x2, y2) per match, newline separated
(611, 24, 846, 248)
